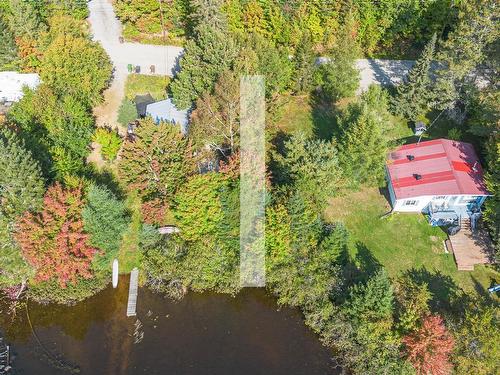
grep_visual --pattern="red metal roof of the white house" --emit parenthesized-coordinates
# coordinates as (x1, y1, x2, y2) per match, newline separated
(387, 139, 490, 199)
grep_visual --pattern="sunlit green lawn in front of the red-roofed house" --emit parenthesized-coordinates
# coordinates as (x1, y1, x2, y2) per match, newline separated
(325, 188, 500, 292)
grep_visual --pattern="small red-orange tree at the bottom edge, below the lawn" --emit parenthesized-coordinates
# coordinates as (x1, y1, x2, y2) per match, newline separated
(403, 316, 454, 375)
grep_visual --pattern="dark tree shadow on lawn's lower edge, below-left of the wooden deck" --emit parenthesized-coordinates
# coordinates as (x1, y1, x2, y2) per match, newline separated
(403, 267, 465, 313)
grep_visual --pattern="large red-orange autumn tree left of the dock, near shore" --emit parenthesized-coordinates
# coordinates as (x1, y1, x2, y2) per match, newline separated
(15, 184, 97, 288)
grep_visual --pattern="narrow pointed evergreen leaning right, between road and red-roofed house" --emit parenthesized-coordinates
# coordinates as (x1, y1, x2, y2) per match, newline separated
(394, 34, 436, 121)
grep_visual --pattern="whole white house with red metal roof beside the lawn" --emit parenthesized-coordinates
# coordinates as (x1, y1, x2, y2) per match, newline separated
(387, 139, 491, 220)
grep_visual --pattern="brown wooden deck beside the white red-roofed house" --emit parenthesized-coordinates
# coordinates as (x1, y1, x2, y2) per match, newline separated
(450, 227, 493, 271)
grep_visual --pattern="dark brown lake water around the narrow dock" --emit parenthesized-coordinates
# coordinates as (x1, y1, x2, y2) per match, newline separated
(0, 278, 339, 375)
